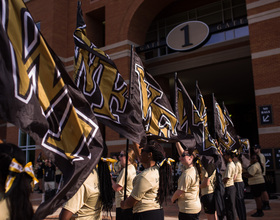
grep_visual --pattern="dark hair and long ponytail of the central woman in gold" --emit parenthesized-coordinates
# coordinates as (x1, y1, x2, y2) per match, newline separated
(147, 141, 172, 205)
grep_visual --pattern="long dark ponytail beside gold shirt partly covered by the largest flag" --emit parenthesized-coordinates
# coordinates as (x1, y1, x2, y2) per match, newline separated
(98, 145, 114, 213)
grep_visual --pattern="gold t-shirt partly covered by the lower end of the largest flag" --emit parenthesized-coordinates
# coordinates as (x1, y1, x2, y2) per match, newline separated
(64, 169, 102, 220)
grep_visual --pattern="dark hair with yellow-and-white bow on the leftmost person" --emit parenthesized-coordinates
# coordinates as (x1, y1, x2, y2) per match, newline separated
(0, 144, 34, 220)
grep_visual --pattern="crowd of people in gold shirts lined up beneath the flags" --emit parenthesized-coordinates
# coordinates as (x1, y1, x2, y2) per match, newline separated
(0, 141, 270, 220)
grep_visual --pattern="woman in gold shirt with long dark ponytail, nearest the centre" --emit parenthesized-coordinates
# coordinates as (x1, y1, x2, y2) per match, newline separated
(121, 141, 172, 220)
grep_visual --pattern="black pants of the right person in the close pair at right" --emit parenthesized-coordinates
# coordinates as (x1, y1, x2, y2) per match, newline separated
(234, 182, 246, 220)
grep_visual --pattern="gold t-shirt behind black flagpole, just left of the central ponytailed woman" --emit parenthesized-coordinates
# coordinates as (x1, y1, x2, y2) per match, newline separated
(115, 164, 136, 208)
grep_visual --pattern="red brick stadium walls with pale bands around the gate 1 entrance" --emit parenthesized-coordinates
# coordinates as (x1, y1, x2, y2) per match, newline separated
(0, 0, 280, 182)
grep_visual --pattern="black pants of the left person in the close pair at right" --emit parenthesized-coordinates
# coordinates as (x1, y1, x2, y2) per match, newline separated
(224, 186, 236, 220)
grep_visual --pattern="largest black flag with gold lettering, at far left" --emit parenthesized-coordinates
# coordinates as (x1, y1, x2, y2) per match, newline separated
(0, 0, 103, 219)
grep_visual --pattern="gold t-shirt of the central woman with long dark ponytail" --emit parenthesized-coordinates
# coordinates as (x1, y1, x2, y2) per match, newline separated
(130, 166, 161, 213)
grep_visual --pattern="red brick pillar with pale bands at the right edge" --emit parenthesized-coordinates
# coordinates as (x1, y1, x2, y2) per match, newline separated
(247, 0, 280, 148)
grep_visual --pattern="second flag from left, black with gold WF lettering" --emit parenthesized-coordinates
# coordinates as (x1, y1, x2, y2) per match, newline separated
(74, 2, 145, 144)
